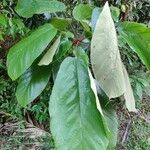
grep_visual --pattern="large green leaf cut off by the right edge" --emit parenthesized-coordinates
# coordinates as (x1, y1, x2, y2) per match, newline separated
(119, 22, 150, 70)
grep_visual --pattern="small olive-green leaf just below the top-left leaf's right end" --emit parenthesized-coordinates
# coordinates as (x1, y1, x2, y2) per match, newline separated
(50, 18, 72, 30)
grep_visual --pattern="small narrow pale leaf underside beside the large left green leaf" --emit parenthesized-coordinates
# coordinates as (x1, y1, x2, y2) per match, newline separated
(38, 36, 61, 66)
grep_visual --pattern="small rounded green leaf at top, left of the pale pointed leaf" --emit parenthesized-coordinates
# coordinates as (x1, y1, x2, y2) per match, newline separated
(73, 4, 92, 21)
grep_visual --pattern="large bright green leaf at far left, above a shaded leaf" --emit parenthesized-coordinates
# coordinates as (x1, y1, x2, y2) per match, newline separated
(7, 24, 57, 80)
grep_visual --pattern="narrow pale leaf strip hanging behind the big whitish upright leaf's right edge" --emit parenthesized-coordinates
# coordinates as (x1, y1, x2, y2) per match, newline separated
(122, 64, 137, 112)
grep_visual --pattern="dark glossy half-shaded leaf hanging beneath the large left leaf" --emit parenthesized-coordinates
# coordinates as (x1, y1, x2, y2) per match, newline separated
(16, 65, 51, 107)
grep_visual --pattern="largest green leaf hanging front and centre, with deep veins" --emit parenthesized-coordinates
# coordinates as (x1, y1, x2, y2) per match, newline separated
(49, 57, 108, 150)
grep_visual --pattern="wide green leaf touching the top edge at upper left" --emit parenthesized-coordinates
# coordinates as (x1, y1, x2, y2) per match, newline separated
(16, 0, 66, 18)
